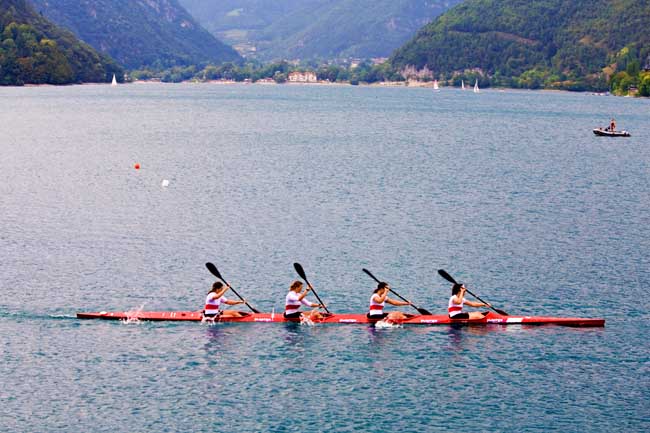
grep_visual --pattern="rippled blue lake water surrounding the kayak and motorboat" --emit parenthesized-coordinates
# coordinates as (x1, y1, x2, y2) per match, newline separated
(0, 85, 650, 432)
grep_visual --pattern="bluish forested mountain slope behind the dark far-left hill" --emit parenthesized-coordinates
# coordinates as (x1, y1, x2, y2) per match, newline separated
(31, 0, 240, 68)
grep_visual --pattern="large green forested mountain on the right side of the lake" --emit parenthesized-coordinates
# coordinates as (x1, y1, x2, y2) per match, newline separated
(390, 0, 650, 90)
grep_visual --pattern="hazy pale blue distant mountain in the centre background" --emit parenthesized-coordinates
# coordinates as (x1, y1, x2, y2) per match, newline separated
(179, 0, 461, 60)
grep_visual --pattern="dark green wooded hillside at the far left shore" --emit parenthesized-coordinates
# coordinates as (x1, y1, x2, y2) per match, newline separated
(0, 0, 124, 85)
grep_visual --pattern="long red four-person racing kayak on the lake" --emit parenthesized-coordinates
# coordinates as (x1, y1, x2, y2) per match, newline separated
(77, 311, 605, 327)
